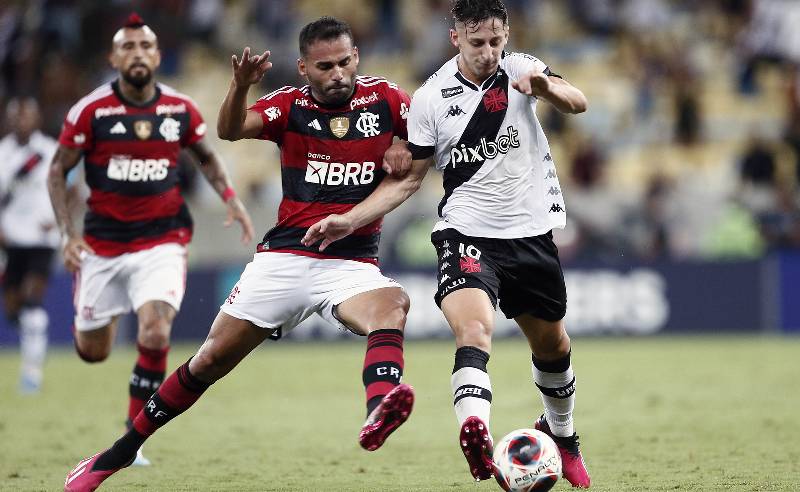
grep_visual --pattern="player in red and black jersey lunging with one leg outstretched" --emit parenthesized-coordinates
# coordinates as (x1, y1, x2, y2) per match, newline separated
(66, 17, 414, 491)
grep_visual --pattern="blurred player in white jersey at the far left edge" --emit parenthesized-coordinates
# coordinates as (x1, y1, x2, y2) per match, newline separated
(0, 98, 58, 393)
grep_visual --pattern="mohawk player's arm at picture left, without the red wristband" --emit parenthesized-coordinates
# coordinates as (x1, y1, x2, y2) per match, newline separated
(47, 145, 94, 272)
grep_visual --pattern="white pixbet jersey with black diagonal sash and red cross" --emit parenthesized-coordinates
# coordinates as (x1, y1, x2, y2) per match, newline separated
(408, 53, 566, 239)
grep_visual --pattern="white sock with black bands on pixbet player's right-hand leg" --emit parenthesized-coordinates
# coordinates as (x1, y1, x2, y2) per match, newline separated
(531, 356, 575, 437)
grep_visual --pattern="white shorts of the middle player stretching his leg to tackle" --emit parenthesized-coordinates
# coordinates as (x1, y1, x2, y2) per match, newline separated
(220, 251, 402, 333)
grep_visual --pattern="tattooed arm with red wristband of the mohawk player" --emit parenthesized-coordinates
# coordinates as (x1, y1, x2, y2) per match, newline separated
(187, 139, 255, 244)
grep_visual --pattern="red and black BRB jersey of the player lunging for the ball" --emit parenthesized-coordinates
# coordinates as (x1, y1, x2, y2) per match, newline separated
(248, 76, 409, 263)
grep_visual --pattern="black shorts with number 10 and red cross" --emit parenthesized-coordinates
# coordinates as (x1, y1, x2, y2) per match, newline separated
(431, 229, 567, 321)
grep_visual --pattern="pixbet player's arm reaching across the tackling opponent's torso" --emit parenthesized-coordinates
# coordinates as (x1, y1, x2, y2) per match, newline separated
(301, 157, 433, 251)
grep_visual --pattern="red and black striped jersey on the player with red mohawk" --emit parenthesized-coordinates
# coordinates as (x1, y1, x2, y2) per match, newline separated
(59, 81, 206, 256)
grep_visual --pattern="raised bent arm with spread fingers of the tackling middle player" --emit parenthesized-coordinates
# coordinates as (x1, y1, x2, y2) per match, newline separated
(217, 47, 272, 141)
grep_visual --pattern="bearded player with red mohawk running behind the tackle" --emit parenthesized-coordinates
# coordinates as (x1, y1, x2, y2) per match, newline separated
(48, 14, 253, 470)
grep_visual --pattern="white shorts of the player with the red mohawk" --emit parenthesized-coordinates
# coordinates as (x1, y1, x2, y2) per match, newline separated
(73, 243, 186, 331)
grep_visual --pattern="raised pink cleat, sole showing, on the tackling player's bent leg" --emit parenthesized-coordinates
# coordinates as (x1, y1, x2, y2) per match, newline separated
(358, 384, 414, 451)
